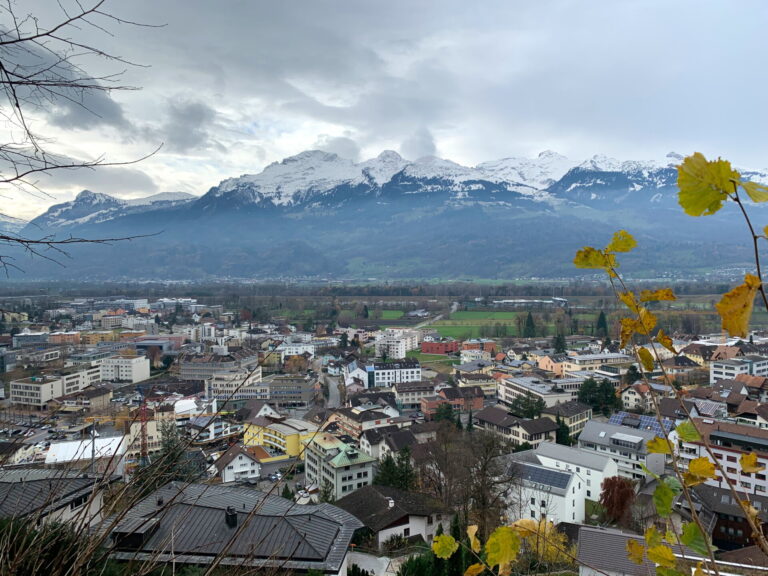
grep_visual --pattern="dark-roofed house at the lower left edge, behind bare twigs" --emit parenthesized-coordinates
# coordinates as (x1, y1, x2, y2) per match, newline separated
(0, 468, 120, 526)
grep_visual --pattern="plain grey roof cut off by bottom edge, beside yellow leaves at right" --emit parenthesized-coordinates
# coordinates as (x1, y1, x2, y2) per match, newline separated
(577, 526, 701, 576)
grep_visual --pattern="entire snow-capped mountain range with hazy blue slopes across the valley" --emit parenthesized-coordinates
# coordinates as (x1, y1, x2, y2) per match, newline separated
(15, 150, 768, 279)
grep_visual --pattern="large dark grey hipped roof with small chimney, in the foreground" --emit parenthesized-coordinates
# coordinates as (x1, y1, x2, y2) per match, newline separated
(101, 483, 362, 572)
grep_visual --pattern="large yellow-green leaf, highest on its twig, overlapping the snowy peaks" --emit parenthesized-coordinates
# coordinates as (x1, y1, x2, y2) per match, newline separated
(677, 152, 741, 216)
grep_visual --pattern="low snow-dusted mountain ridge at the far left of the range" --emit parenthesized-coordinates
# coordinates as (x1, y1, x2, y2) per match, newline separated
(29, 190, 196, 230)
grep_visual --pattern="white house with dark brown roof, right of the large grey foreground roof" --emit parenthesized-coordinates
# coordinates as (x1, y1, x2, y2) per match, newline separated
(335, 486, 451, 549)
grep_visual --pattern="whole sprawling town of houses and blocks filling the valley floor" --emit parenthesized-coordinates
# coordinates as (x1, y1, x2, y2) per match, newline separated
(0, 297, 768, 574)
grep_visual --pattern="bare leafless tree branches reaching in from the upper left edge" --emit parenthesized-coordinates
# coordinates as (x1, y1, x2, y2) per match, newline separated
(0, 0, 157, 270)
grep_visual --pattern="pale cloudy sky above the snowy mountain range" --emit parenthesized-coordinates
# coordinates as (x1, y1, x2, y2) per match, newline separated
(6, 0, 768, 218)
